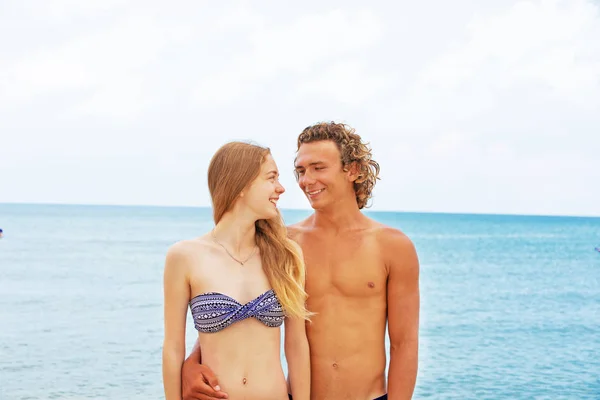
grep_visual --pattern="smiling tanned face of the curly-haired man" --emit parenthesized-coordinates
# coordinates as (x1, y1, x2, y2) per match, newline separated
(294, 140, 355, 210)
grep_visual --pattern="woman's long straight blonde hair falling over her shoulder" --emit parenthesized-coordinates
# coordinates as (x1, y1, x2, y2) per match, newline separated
(208, 142, 310, 319)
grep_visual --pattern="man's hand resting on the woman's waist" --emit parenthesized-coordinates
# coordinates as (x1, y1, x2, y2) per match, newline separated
(181, 358, 227, 400)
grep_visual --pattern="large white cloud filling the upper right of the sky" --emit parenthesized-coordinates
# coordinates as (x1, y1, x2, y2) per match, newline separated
(378, 1, 600, 161)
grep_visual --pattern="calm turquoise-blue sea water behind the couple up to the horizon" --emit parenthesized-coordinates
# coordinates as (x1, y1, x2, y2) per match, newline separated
(0, 204, 600, 400)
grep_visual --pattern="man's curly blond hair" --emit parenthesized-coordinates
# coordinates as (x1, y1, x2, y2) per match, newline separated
(296, 122, 380, 209)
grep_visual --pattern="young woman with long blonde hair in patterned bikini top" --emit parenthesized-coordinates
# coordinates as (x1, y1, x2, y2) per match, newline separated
(163, 142, 310, 400)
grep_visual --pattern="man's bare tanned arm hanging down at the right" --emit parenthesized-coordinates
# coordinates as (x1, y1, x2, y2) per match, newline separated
(384, 230, 420, 400)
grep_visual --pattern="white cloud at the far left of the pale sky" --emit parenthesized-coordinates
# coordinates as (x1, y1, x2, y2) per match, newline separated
(0, 9, 189, 116)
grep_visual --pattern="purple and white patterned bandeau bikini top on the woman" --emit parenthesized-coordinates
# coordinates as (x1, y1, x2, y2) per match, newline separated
(190, 289, 285, 333)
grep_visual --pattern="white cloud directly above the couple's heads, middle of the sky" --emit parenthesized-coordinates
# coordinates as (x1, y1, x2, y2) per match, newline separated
(192, 10, 382, 107)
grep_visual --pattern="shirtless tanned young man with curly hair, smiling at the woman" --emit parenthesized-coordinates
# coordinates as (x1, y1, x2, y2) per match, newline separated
(182, 123, 419, 400)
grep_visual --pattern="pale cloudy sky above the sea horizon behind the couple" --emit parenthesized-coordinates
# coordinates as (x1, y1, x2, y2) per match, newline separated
(0, 0, 600, 216)
